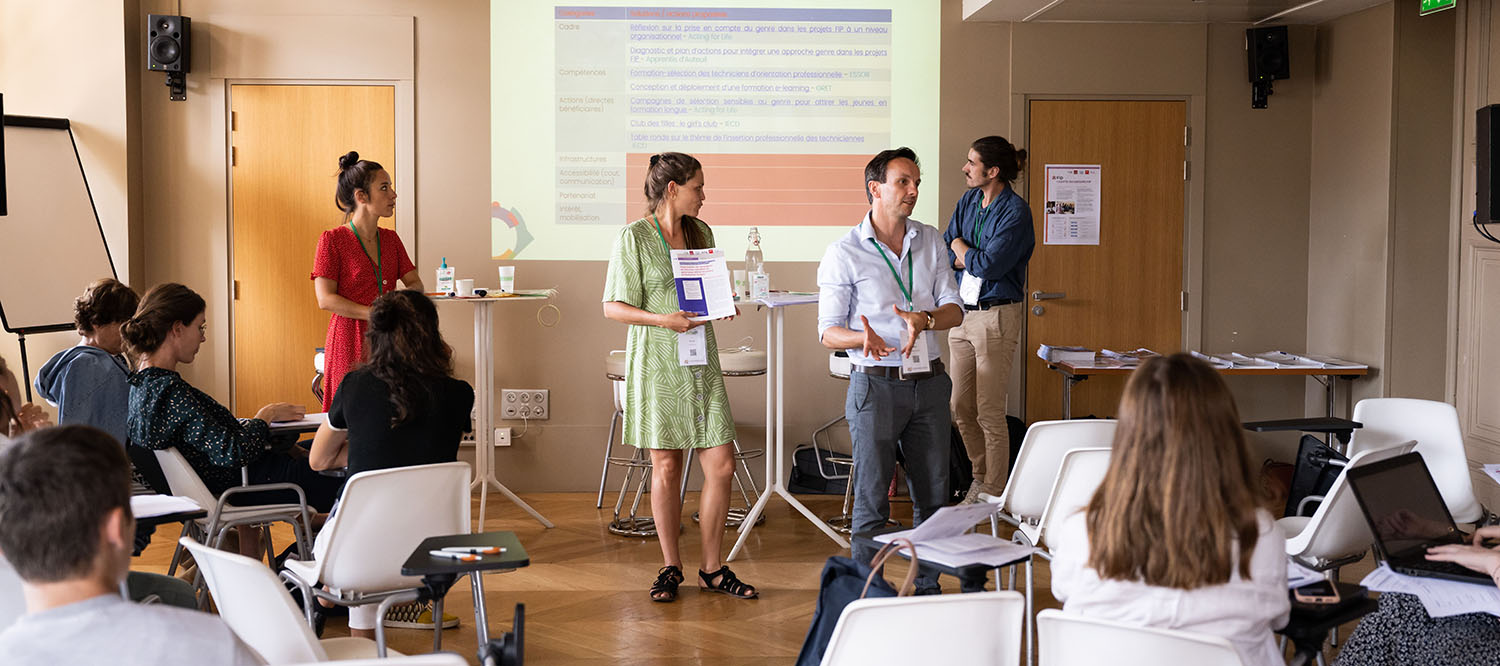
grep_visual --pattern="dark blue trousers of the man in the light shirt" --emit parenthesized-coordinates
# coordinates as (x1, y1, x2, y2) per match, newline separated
(845, 368, 953, 591)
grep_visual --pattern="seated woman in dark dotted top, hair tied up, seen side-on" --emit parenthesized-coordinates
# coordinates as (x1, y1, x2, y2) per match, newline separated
(122, 284, 344, 557)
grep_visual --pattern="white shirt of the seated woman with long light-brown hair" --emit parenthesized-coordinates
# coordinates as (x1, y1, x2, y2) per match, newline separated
(1047, 510, 1292, 666)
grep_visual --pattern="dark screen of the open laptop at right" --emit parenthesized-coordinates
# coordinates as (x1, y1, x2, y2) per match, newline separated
(1349, 453, 1464, 560)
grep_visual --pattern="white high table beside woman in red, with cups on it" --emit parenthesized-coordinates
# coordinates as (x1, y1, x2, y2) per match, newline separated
(432, 290, 557, 531)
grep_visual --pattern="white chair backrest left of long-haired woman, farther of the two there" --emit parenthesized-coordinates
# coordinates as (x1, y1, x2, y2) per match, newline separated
(1001, 419, 1116, 521)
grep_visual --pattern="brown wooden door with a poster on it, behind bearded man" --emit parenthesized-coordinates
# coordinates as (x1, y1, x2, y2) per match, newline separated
(1025, 101, 1187, 423)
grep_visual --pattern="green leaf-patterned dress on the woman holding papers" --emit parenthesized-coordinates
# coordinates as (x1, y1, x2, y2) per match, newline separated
(605, 218, 735, 449)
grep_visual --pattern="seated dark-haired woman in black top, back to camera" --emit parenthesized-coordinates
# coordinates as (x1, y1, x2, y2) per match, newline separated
(309, 290, 474, 638)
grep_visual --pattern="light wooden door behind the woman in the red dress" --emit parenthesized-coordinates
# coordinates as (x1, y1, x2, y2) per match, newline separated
(230, 86, 405, 417)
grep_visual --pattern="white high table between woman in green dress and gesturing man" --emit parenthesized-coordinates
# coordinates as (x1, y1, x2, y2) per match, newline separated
(725, 293, 849, 563)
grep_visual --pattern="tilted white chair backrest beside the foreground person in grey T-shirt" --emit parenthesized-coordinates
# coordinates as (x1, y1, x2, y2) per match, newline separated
(177, 537, 329, 663)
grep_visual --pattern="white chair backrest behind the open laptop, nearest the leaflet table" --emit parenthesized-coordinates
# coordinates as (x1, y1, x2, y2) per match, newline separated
(1349, 398, 1484, 522)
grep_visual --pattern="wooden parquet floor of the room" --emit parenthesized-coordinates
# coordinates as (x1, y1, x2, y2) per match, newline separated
(135, 494, 1370, 666)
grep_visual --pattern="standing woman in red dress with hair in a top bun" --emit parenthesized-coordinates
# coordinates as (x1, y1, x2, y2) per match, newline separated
(312, 150, 422, 411)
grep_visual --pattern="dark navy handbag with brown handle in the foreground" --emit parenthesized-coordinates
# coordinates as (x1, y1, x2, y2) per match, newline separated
(797, 539, 918, 666)
